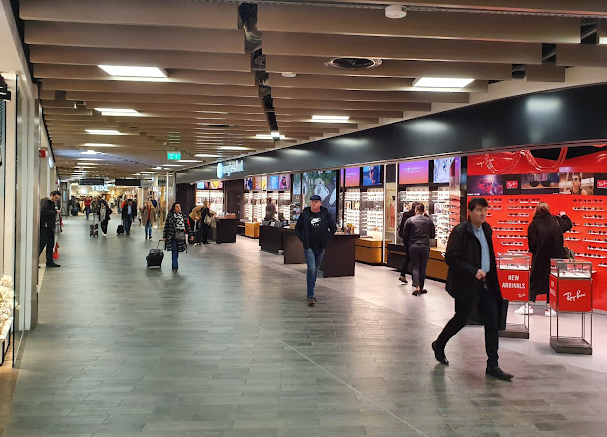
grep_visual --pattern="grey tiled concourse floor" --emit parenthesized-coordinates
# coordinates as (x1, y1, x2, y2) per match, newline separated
(6, 218, 607, 437)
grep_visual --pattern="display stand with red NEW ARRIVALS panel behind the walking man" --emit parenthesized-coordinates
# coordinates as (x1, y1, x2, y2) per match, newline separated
(496, 254, 531, 339)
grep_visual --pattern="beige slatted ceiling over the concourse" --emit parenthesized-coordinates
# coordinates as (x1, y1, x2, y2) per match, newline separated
(19, 0, 607, 180)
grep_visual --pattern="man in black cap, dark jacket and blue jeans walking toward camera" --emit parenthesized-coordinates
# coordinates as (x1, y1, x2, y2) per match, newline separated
(295, 194, 337, 306)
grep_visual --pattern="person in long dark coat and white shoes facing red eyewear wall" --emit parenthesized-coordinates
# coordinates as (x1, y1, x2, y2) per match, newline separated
(515, 202, 573, 316)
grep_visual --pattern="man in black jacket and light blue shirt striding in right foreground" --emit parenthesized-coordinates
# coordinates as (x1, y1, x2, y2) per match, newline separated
(432, 197, 513, 381)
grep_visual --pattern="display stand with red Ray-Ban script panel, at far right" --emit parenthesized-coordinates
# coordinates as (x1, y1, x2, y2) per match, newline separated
(549, 259, 593, 355)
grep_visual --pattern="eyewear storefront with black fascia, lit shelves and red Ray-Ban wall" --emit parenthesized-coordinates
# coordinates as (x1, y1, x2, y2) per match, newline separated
(176, 85, 607, 310)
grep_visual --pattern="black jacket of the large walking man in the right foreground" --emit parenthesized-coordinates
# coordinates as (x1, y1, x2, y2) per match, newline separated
(445, 220, 499, 298)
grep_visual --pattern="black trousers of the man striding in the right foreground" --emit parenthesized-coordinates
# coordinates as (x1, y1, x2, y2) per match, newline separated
(436, 281, 501, 367)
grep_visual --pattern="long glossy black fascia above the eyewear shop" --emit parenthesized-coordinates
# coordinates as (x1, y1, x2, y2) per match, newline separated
(177, 85, 607, 182)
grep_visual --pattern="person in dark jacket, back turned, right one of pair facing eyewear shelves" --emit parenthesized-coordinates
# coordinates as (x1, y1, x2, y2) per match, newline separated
(403, 203, 436, 296)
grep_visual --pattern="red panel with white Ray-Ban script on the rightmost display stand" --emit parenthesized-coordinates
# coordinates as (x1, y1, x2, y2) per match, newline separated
(550, 275, 592, 312)
